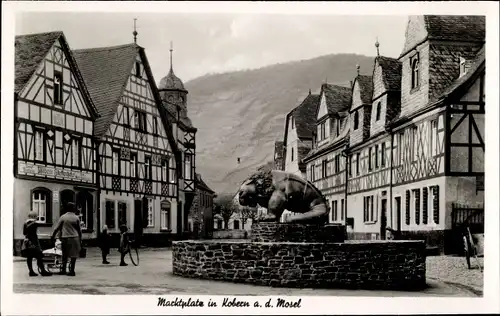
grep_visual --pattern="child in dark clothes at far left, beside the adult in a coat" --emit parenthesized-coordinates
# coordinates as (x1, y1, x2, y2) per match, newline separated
(21, 211, 52, 276)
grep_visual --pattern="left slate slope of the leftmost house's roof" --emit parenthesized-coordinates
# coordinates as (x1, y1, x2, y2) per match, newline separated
(14, 31, 63, 92)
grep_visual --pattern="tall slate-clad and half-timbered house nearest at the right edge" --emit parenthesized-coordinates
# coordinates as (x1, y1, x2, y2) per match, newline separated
(389, 16, 485, 251)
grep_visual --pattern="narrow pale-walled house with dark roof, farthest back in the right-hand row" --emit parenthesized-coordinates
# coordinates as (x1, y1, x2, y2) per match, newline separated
(283, 90, 319, 178)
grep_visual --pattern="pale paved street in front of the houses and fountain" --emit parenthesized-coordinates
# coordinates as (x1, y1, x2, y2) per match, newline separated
(14, 248, 475, 297)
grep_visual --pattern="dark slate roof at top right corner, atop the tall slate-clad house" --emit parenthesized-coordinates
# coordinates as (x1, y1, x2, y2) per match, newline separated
(424, 15, 486, 42)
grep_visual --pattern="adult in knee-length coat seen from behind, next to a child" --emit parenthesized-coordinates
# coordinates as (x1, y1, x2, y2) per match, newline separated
(52, 202, 82, 276)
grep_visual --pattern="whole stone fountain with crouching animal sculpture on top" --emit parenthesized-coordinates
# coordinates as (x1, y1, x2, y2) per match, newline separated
(172, 171, 426, 290)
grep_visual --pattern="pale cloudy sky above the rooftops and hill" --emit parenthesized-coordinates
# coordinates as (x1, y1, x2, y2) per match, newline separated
(15, 12, 408, 82)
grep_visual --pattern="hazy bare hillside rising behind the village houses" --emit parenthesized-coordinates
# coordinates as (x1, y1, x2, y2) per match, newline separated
(185, 54, 373, 192)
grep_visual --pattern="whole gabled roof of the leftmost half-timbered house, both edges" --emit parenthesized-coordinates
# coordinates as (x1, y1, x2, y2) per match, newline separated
(14, 31, 98, 118)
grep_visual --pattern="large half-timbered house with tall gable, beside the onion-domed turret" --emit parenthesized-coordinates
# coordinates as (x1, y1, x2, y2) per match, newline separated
(74, 43, 183, 245)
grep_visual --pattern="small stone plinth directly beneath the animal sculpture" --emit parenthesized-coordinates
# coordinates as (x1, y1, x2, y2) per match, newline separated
(250, 222, 346, 242)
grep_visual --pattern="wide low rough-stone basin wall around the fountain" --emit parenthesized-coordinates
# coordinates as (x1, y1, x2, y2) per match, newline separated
(172, 240, 426, 290)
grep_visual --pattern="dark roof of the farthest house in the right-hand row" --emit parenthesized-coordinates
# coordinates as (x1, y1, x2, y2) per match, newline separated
(290, 94, 319, 138)
